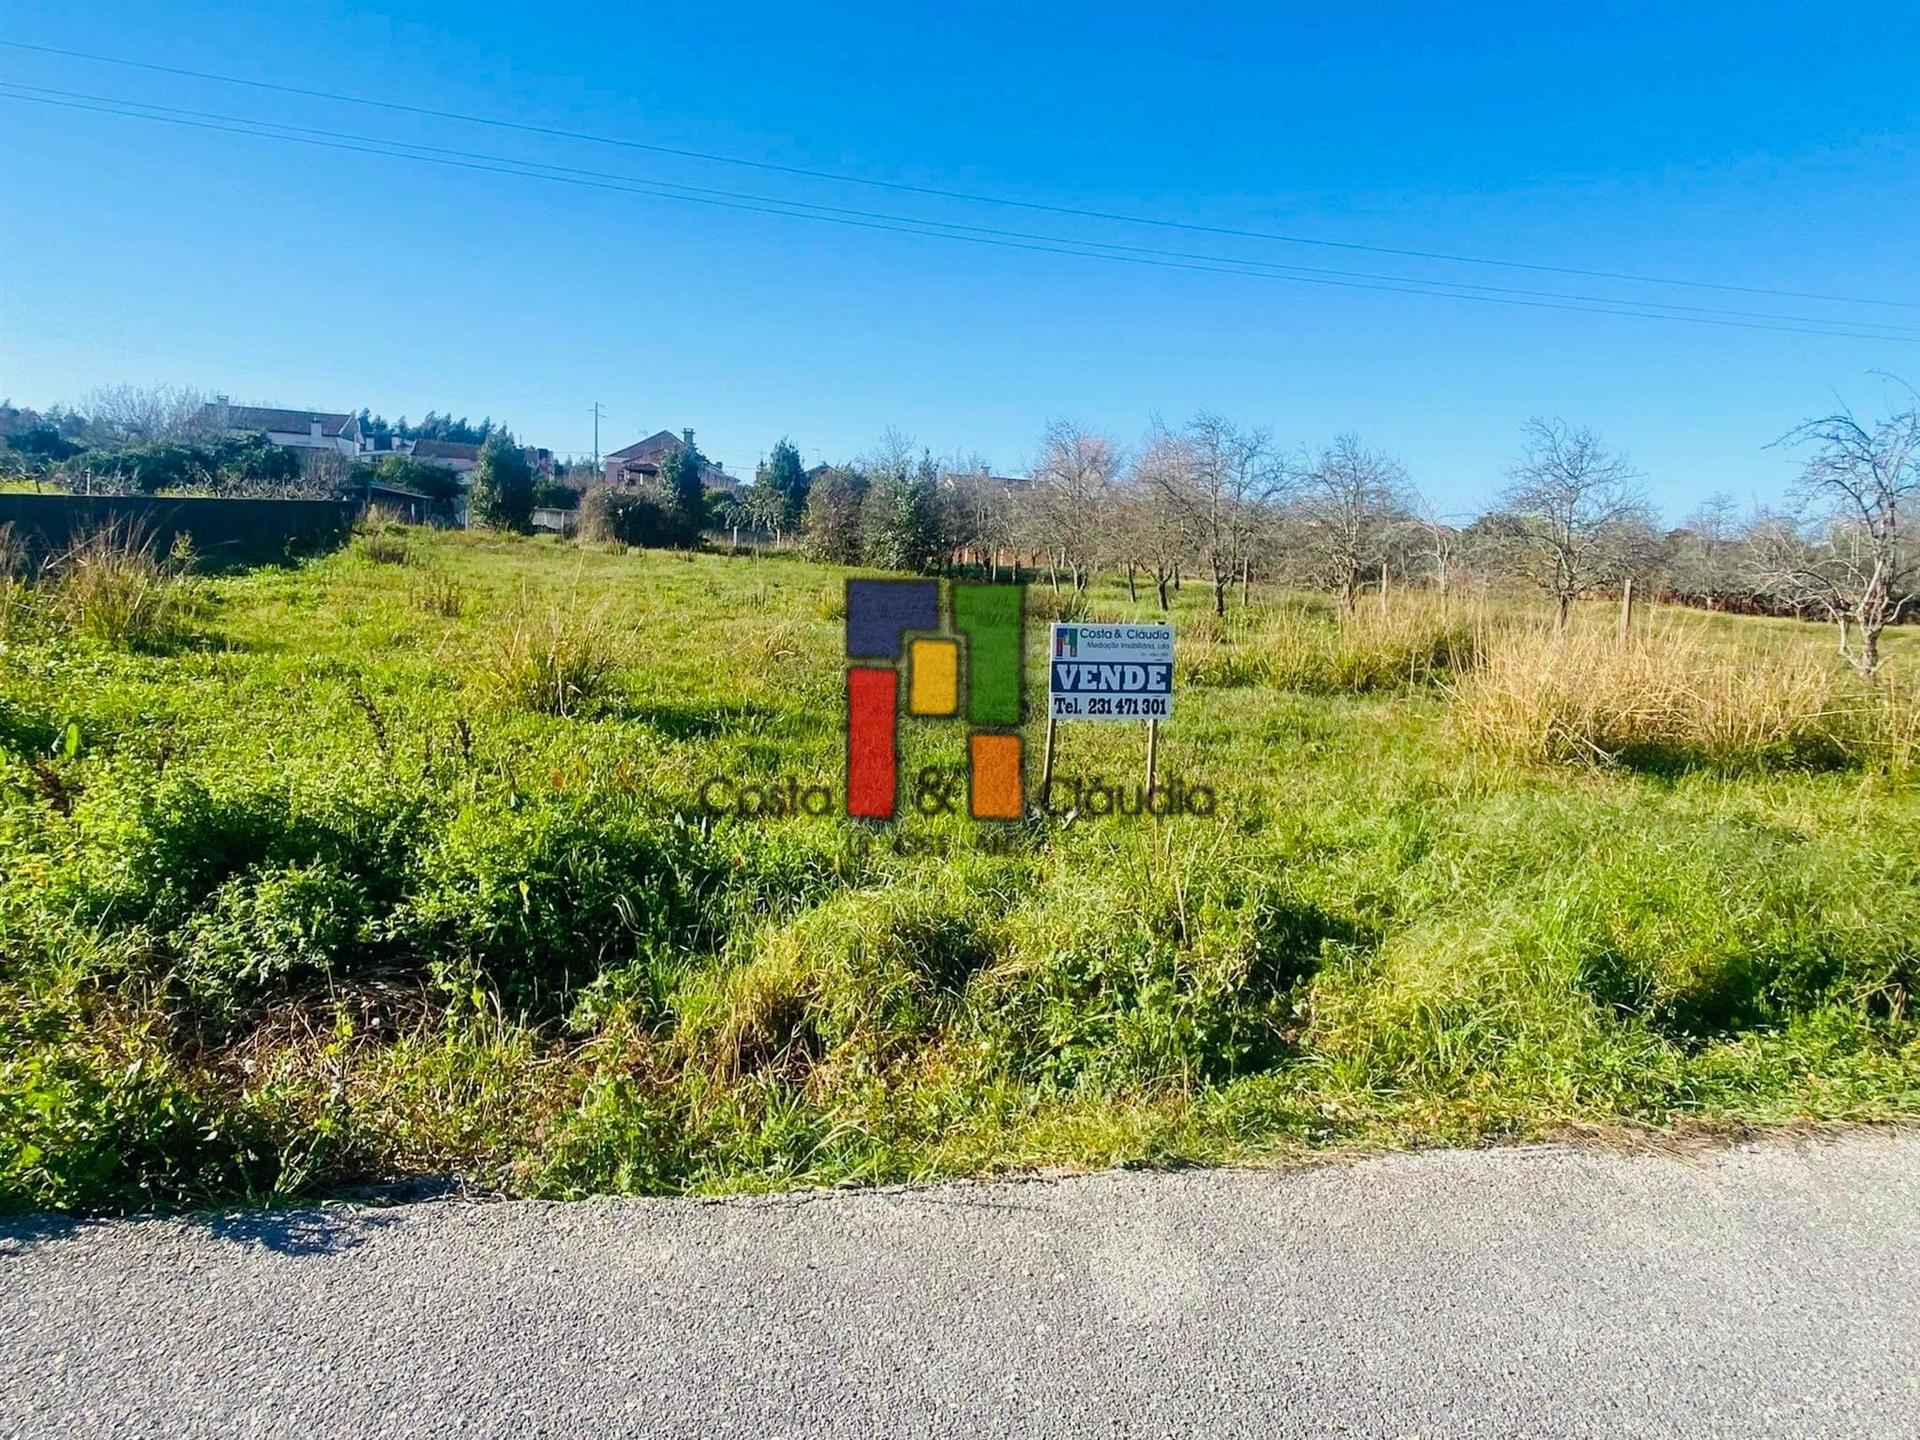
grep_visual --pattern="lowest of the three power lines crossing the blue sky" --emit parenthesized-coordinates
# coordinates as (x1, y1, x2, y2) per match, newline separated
(0, 86, 1914, 344)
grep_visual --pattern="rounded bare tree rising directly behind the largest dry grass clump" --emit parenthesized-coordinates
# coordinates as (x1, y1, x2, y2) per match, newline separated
(1501, 419, 1645, 630)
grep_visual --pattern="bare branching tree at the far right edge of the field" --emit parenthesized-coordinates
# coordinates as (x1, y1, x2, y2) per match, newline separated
(1764, 388, 1920, 676)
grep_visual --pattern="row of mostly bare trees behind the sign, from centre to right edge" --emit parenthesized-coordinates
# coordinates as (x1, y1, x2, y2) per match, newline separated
(756, 392, 1920, 672)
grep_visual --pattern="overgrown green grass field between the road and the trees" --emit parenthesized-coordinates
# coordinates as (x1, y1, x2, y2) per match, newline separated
(0, 530, 1920, 1210)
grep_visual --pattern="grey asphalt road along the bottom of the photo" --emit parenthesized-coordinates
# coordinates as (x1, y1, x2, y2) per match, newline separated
(0, 1131, 1920, 1436)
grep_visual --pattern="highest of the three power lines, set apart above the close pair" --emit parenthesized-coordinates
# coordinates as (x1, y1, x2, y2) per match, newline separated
(0, 40, 1920, 309)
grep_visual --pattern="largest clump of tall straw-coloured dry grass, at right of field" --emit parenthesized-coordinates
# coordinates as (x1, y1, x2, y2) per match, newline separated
(1453, 624, 1920, 772)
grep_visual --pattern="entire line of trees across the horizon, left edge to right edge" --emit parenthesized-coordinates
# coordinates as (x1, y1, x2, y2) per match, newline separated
(0, 386, 1920, 672)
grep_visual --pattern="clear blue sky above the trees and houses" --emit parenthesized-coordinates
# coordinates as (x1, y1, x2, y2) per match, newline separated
(0, 0, 1920, 516)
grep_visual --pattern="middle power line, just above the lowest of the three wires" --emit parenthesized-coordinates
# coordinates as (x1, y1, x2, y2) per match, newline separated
(0, 81, 1920, 334)
